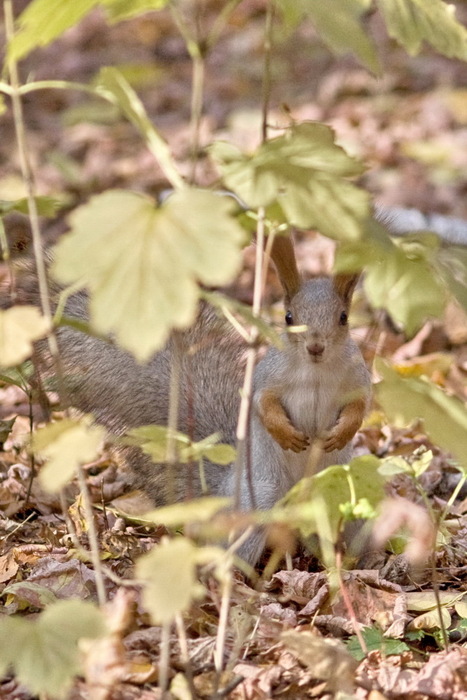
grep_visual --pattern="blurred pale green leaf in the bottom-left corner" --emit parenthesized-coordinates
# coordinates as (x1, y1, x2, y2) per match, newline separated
(0, 600, 105, 697)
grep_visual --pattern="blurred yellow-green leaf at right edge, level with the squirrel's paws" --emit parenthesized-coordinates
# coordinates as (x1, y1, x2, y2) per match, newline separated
(376, 362, 467, 467)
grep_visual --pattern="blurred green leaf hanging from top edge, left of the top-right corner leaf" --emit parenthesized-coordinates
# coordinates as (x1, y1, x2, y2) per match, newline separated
(279, 0, 380, 73)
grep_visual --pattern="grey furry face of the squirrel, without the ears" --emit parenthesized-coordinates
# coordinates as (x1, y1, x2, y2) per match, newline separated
(285, 277, 351, 364)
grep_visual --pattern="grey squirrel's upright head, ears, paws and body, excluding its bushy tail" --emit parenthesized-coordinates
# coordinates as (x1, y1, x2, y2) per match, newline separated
(225, 237, 371, 562)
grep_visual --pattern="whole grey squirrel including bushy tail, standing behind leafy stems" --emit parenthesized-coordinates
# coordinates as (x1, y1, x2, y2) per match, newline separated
(8, 236, 371, 564)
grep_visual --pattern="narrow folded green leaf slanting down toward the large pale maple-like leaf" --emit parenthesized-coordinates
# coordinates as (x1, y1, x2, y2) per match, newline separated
(96, 68, 183, 188)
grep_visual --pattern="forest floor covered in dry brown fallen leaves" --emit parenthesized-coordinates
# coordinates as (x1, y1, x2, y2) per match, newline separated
(0, 0, 467, 700)
